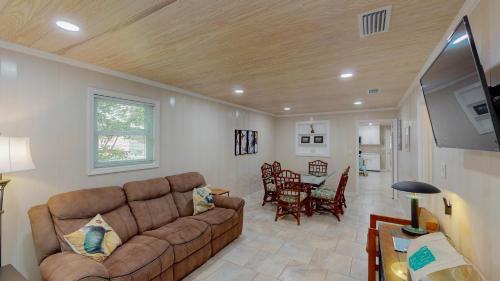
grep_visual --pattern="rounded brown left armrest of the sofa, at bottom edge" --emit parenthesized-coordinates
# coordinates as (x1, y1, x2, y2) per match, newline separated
(40, 252, 109, 281)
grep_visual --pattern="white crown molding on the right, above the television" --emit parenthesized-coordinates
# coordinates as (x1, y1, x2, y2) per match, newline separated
(397, 0, 480, 109)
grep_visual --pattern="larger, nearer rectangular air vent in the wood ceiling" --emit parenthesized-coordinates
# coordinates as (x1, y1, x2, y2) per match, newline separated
(358, 6, 392, 37)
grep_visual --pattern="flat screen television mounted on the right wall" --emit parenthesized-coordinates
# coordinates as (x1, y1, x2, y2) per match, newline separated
(420, 17, 500, 151)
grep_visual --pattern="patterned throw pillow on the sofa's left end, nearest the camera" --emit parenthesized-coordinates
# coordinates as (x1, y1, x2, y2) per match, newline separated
(64, 214, 122, 262)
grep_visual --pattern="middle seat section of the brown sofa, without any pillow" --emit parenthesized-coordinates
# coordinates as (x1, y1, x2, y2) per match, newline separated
(123, 178, 212, 280)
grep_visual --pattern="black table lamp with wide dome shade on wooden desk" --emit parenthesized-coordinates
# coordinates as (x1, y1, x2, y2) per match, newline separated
(392, 181, 441, 235)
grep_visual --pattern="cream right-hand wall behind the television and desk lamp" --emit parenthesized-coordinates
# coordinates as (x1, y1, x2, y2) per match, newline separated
(398, 0, 500, 280)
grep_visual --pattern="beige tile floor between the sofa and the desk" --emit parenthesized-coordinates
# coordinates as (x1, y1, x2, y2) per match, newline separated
(185, 172, 402, 281)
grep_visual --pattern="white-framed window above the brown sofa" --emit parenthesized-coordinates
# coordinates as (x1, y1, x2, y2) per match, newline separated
(89, 89, 160, 175)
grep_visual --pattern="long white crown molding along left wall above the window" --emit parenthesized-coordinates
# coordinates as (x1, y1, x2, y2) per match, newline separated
(0, 40, 276, 117)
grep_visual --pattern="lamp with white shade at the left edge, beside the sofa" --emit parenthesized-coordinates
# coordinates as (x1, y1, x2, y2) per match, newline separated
(0, 136, 35, 266)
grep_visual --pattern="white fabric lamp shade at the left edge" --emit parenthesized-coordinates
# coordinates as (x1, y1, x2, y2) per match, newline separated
(0, 137, 35, 173)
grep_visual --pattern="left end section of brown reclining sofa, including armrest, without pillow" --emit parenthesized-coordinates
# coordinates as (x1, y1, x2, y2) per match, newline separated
(29, 187, 174, 281)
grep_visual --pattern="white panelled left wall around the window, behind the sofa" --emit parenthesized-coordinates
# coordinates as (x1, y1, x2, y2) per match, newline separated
(0, 49, 275, 280)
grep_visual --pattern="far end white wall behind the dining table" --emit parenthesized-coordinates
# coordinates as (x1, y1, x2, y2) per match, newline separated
(274, 110, 397, 192)
